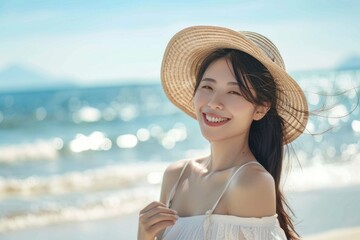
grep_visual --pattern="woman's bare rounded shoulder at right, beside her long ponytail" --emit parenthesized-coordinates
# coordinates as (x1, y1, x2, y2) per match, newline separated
(226, 164, 276, 217)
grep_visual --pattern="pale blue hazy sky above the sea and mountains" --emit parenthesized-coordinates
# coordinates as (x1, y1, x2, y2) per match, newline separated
(0, 0, 360, 85)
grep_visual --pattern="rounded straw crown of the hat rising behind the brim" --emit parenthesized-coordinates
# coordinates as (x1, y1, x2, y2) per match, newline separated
(240, 31, 285, 70)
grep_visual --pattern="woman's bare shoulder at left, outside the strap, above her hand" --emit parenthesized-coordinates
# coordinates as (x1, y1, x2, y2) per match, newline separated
(160, 159, 190, 203)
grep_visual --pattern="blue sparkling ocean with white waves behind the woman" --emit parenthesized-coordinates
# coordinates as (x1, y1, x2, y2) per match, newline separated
(0, 70, 360, 237)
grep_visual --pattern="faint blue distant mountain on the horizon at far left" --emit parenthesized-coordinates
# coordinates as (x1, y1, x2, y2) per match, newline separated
(0, 65, 75, 92)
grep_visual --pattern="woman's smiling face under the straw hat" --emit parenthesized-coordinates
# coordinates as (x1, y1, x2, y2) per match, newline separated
(194, 58, 259, 142)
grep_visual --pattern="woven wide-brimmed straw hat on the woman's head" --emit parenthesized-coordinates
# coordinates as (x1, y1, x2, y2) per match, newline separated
(161, 26, 308, 144)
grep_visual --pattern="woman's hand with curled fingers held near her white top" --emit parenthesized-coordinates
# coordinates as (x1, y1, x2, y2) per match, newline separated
(138, 201, 178, 240)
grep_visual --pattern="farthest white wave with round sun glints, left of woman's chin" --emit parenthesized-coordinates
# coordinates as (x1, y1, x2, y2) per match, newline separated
(0, 122, 188, 164)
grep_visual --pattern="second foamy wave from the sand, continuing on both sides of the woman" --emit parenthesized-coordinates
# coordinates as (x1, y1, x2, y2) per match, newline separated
(0, 148, 360, 198)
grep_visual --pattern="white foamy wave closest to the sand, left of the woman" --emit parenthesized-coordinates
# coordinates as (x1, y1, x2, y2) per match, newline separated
(0, 187, 159, 232)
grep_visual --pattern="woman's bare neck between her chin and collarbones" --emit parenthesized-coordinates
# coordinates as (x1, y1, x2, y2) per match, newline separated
(207, 134, 255, 172)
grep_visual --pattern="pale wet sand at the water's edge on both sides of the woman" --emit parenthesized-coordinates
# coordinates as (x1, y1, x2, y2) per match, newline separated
(1, 186, 360, 240)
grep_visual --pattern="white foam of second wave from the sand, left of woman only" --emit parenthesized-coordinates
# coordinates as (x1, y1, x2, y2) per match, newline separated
(0, 163, 168, 198)
